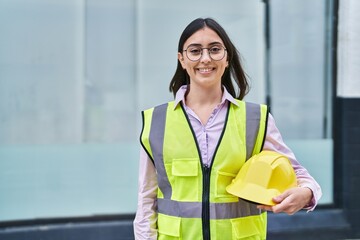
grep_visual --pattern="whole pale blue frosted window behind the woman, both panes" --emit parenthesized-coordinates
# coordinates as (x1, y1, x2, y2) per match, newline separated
(0, 0, 332, 221)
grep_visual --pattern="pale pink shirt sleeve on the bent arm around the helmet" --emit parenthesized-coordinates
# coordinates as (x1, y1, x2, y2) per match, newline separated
(263, 114, 322, 211)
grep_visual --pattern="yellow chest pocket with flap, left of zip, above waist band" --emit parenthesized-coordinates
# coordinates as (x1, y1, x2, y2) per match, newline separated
(171, 158, 201, 201)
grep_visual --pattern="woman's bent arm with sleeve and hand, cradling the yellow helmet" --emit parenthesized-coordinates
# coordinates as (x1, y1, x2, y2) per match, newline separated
(259, 114, 322, 214)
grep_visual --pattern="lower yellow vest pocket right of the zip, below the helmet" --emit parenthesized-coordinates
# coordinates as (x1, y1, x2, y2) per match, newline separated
(231, 216, 265, 240)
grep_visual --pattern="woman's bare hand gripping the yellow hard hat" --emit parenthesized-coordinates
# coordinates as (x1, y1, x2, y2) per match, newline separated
(257, 187, 313, 215)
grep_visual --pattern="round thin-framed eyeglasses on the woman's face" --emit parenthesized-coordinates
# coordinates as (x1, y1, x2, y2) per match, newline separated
(183, 45, 226, 62)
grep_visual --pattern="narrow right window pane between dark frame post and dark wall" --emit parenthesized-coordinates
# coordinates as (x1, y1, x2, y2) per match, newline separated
(268, 0, 333, 204)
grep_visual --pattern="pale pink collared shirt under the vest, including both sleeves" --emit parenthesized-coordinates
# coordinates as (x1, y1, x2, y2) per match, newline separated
(134, 86, 322, 240)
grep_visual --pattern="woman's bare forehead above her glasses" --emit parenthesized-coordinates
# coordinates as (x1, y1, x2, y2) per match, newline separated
(184, 27, 224, 48)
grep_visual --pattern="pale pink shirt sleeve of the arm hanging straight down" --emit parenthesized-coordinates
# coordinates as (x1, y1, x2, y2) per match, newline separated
(133, 148, 158, 240)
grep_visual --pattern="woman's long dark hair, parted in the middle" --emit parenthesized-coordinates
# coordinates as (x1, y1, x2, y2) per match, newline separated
(169, 18, 249, 100)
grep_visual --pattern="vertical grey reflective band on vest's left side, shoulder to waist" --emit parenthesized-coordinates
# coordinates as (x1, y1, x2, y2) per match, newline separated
(149, 103, 172, 199)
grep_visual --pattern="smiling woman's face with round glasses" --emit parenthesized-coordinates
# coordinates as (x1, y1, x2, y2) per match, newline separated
(178, 27, 228, 88)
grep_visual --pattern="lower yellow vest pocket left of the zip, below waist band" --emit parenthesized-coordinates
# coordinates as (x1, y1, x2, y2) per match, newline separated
(157, 213, 181, 239)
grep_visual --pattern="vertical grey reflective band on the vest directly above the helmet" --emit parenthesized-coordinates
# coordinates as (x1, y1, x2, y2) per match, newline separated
(245, 102, 261, 160)
